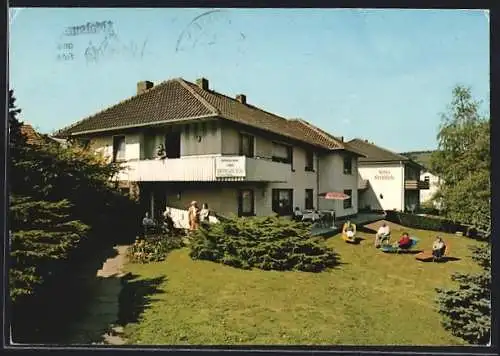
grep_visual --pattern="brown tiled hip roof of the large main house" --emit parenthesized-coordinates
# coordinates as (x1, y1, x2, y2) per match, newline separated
(57, 78, 360, 154)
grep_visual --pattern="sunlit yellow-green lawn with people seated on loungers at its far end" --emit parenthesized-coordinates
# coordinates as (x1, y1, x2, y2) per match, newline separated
(119, 224, 478, 345)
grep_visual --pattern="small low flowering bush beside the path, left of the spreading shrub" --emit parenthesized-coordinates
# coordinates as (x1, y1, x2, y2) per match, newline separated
(127, 234, 183, 263)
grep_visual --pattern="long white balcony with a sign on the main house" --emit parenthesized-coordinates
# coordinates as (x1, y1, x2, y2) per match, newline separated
(118, 155, 291, 182)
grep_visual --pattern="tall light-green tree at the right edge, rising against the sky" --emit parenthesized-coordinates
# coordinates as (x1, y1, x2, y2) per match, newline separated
(431, 86, 491, 234)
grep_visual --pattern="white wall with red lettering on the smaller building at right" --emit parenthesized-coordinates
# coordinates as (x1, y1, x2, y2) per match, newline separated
(358, 162, 405, 210)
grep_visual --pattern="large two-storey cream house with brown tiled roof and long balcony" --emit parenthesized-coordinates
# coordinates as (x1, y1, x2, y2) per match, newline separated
(60, 79, 360, 217)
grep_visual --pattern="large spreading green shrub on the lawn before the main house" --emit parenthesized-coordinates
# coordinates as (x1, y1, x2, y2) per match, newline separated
(190, 217, 337, 272)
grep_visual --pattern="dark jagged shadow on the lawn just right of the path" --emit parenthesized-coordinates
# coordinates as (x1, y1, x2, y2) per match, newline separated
(117, 273, 167, 326)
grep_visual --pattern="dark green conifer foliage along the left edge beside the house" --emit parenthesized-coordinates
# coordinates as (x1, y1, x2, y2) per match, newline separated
(9, 90, 139, 313)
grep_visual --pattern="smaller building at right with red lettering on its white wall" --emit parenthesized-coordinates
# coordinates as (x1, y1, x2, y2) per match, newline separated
(348, 139, 429, 211)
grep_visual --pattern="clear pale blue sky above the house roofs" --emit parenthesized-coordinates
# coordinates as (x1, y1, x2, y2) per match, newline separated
(9, 8, 489, 151)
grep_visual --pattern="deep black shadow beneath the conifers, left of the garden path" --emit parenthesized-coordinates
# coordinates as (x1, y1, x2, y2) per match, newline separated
(11, 245, 118, 344)
